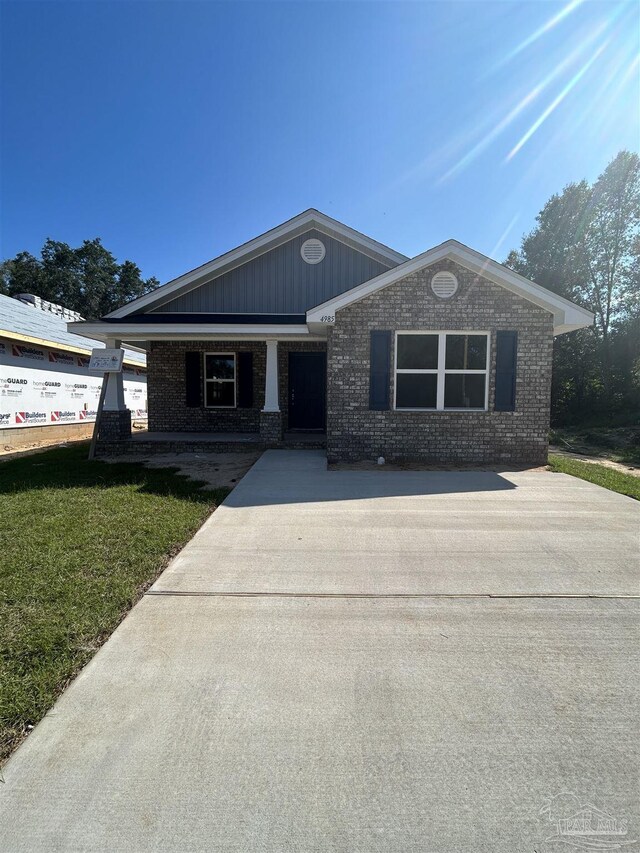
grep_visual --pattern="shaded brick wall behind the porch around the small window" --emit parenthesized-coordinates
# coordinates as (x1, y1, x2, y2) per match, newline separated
(147, 341, 326, 432)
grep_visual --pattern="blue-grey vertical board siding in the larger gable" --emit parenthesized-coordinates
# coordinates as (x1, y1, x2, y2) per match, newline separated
(152, 229, 394, 314)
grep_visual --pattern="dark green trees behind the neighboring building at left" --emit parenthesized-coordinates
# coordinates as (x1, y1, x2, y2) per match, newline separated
(0, 237, 159, 320)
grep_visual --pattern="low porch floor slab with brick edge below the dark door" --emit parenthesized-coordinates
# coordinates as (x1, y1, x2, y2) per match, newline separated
(96, 431, 326, 456)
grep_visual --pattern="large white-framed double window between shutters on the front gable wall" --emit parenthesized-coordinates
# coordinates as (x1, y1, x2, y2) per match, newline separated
(395, 332, 489, 411)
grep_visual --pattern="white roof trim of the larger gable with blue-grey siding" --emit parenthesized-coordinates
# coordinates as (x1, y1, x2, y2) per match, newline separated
(107, 208, 407, 319)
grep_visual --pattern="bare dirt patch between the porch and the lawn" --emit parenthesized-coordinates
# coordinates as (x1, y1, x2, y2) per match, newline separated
(101, 450, 262, 489)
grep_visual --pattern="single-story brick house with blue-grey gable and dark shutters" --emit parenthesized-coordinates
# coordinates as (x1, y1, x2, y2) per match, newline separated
(70, 210, 593, 465)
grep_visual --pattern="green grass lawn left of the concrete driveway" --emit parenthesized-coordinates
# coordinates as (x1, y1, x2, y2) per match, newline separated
(0, 445, 228, 761)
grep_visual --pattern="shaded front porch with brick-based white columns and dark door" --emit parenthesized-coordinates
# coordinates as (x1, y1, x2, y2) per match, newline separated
(96, 338, 326, 456)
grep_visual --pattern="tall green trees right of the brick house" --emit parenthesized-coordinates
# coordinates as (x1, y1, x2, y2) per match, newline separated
(505, 151, 640, 424)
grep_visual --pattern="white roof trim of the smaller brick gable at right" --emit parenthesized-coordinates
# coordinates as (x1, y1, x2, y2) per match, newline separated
(307, 240, 594, 335)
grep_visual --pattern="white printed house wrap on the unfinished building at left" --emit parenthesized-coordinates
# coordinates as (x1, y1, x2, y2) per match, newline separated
(0, 339, 147, 429)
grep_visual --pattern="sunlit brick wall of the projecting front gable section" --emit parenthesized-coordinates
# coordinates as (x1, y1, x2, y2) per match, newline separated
(327, 261, 553, 464)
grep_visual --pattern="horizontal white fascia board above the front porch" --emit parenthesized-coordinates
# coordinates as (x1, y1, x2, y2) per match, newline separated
(67, 321, 314, 341)
